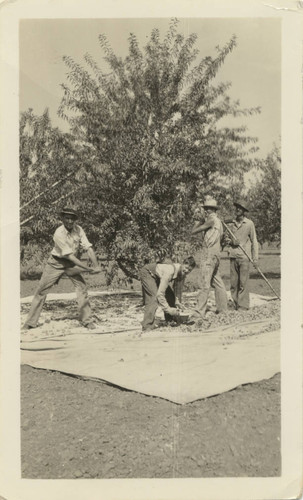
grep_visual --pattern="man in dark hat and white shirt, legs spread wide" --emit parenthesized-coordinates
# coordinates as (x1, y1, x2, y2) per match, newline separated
(22, 207, 101, 331)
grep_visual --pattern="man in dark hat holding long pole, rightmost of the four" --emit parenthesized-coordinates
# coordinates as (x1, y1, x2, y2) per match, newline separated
(228, 201, 258, 310)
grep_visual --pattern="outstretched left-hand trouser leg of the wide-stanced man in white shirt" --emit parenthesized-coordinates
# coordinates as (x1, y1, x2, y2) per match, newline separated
(25, 264, 64, 328)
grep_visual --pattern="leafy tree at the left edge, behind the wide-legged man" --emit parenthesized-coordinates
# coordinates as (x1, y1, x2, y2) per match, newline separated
(19, 109, 97, 249)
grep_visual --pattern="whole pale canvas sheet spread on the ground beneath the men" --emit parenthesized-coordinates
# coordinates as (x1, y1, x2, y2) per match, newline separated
(21, 293, 280, 404)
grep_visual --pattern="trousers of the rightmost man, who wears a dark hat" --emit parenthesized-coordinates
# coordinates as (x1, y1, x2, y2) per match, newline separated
(230, 258, 249, 309)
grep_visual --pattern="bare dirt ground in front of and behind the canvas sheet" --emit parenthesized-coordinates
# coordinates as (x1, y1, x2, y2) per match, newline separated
(21, 254, 281, 479)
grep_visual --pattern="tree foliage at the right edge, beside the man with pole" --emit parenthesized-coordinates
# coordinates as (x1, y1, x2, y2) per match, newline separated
(248, 147, 281, 244)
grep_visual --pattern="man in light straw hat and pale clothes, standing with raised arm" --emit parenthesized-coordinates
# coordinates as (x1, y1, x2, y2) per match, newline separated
(192, 197, 227, 318)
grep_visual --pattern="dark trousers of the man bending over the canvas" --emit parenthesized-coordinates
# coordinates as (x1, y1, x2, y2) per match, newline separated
(139, 264, 176, 330)
